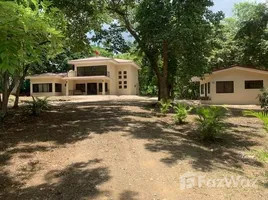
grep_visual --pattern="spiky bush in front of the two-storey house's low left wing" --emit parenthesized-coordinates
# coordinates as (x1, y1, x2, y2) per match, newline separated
(27, 96, 48, 116)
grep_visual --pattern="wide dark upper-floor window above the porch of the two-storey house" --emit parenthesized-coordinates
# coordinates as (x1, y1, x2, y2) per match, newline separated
(77, 65, 108, 76)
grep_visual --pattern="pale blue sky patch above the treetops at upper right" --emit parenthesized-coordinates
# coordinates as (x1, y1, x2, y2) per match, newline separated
(213, 0, 265, 17)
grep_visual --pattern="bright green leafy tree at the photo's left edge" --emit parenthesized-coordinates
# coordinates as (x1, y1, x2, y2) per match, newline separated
(0, 0, 62, 115)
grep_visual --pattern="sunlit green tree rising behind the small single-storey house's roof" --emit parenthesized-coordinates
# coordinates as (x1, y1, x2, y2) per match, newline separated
(211, 2, 268, 68)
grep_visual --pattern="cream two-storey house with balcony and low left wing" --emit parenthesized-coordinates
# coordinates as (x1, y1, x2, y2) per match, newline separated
(27, 56, 140, 96)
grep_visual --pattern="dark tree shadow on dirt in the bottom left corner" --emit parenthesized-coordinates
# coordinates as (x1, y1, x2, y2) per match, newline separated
(1, 160, 111, 200)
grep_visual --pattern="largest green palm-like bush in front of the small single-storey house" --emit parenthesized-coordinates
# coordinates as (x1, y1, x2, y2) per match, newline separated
(196, 106, 227, 141)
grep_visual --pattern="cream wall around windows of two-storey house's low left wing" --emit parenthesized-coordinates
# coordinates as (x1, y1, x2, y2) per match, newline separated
(30, 78, 64, 97)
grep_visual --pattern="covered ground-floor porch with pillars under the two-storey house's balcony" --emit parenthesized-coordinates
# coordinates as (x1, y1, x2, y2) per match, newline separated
(64, 76, 110, 96)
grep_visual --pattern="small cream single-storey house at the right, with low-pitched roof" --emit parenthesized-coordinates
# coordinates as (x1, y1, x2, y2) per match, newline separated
(193, 66, 268, 105)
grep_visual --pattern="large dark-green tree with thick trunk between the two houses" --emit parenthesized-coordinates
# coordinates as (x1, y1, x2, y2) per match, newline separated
(106, 0, 222, 99)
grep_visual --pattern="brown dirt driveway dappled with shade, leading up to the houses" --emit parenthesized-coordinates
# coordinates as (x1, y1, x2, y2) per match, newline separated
(0, 99, 268, 200)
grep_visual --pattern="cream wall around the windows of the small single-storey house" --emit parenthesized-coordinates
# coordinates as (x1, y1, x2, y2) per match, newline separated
(200, 69, 268, 105)
